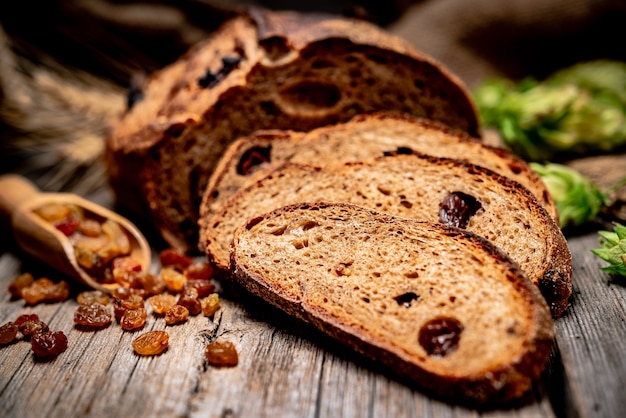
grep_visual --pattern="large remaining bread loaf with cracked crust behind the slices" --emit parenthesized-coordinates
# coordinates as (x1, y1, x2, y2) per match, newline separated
(107, 9, 478, 249)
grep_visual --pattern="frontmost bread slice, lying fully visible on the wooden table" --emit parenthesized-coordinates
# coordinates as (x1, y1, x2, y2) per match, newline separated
(232, 203, 554, 403)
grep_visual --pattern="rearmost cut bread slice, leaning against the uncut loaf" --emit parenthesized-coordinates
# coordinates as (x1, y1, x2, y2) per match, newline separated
(199, 112, 558, 245)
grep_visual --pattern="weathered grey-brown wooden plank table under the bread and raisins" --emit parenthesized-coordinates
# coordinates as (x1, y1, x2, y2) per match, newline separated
(0, 175, 626, 418)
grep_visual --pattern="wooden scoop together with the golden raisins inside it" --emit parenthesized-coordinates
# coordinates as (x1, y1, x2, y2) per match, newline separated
(0, 174, 151, 291)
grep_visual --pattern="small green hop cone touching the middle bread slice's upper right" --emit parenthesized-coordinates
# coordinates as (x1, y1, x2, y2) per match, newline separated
(530, 162, 606, 228)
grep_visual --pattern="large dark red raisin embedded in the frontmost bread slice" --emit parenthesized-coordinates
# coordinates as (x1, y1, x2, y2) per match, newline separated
(418, 317, 463, 357)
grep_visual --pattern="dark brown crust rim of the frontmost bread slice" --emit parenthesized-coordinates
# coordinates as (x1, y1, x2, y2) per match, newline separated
(231, 202, 554, 404)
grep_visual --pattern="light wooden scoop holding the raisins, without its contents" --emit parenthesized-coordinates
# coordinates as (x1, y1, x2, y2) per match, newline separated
(0, 174, 151, 292)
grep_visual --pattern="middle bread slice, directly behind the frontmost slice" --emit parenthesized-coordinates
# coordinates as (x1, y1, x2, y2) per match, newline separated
(205, 155, 572, 316)
